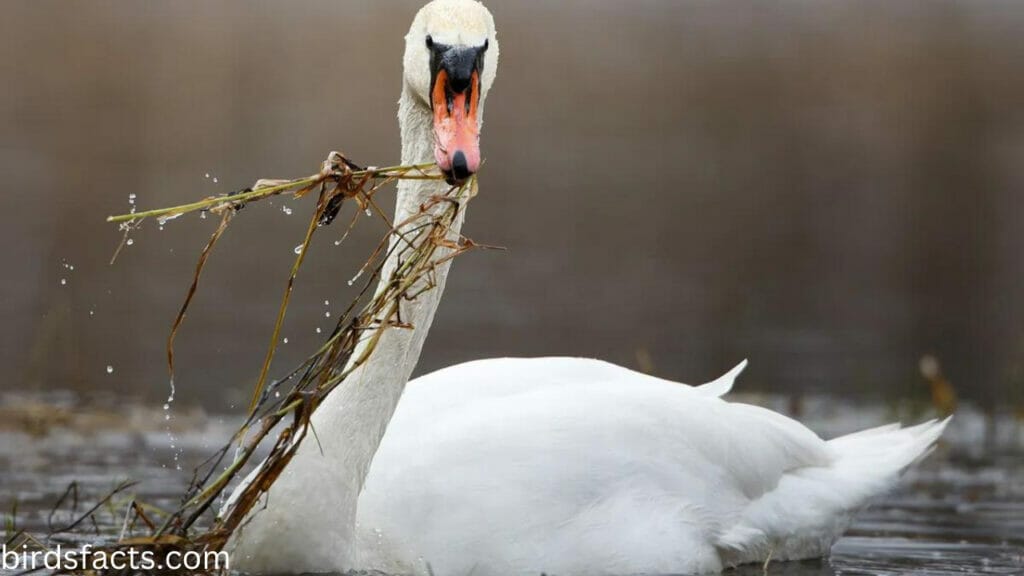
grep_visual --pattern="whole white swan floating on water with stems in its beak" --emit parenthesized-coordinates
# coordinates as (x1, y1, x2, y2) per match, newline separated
(227, 0, 946, 576)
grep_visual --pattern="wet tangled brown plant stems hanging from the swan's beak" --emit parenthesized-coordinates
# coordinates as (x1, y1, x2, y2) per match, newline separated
(5, 152, 485, 574)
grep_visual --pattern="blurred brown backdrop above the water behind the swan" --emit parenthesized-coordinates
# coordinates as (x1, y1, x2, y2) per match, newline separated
(0, 0, 1024, 410)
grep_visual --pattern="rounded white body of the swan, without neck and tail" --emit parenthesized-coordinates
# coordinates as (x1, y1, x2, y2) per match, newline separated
(358, 358, 942, 575)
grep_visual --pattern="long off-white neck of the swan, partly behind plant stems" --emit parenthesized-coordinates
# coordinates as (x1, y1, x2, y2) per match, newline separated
(302, 83, 464, 560)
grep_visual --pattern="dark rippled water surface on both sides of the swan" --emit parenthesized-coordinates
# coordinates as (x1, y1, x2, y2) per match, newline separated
(0, 399, 1024, 576)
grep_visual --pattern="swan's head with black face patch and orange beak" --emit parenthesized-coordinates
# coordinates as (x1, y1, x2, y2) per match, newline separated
(404, 0, 498, 183)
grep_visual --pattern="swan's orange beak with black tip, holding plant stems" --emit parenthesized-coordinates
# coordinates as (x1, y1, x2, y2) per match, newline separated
(430, 70, 480, 186)
